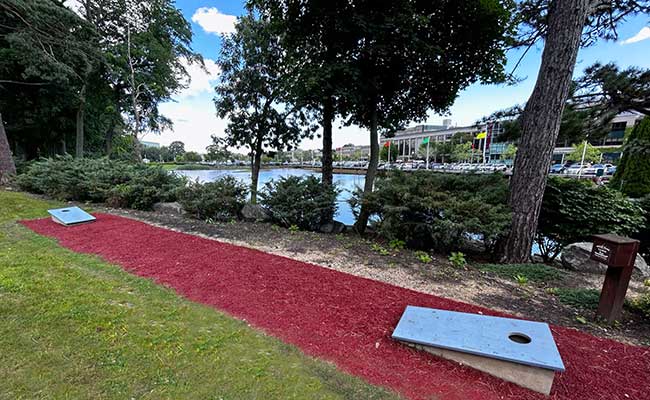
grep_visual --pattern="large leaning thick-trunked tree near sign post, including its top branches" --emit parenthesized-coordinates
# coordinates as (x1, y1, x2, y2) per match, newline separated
(501, 0, 650, 263)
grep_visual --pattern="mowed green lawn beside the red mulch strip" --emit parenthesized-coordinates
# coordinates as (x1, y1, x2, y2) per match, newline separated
(0, 191, 397, 400)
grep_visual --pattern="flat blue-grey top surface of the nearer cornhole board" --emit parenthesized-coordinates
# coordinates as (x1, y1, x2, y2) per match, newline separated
(393, 306, 564, 371)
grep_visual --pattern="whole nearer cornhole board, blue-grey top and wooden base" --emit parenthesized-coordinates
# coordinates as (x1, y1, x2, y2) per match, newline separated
(393, 306, 564, 395)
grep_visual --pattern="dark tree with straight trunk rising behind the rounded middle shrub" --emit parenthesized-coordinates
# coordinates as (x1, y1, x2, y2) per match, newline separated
(249, 0, 357, 191)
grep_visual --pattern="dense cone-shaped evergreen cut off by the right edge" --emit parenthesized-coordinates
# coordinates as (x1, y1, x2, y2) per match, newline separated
(610, 117, 650, 197)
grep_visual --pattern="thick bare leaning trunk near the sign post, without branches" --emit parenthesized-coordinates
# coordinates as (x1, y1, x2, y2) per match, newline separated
(501, 0, 590, 263)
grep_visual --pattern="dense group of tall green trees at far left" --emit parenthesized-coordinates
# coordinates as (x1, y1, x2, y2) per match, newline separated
(0, 0, 203, 171)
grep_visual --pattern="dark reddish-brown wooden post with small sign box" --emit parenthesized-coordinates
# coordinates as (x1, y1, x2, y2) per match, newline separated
(591, 234, 639, 323)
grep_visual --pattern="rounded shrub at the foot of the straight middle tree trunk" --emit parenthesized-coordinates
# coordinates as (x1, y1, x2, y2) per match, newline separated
(259, 176, 339, 231)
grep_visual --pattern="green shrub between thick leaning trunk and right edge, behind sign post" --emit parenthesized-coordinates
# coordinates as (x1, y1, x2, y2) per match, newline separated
(536, 177, 645, 261)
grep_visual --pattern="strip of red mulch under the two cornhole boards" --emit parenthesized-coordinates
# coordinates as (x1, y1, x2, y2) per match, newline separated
(23, 214, 650, 400)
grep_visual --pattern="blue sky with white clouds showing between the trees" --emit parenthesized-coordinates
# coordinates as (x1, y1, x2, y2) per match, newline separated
(145, 0, 650, 152)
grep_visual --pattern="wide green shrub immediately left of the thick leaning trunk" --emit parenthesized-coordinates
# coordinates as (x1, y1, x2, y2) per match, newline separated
(350, 171, 510, 252)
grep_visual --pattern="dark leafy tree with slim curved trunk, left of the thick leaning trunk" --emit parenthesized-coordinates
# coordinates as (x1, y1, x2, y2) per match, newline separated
(344, 0, 510, 232)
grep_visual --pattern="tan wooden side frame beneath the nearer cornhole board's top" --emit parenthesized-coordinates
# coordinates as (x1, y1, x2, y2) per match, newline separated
(404, 342, 555, 396)
